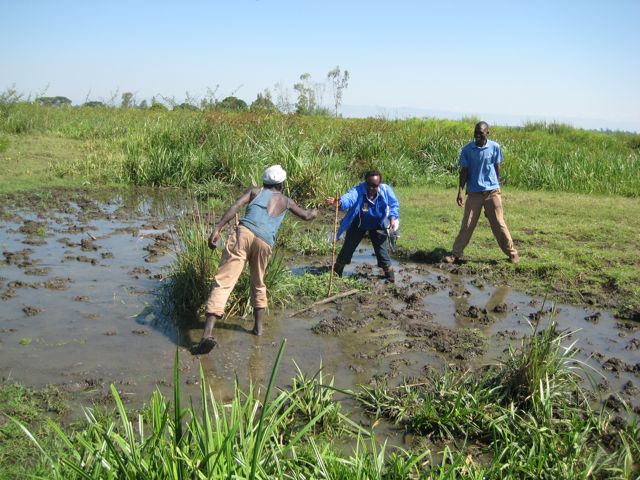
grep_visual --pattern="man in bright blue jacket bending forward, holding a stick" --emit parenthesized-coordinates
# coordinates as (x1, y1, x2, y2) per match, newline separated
(325, 170, 400, 282)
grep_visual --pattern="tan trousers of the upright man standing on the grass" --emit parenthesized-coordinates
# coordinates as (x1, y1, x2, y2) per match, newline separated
(452, 189, 518, 257)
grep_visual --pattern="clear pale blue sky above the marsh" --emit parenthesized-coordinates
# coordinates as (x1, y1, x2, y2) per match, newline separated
(0, 0, 640, 131)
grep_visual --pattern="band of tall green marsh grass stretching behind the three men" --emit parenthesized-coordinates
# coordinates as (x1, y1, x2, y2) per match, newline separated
(0, 104, 640, 197)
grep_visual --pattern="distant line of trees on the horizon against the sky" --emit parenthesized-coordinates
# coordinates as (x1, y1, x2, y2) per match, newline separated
(0, 66, 349, 117)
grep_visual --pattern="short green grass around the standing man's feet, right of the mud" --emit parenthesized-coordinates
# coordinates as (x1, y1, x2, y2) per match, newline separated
(397, 187, 640, 316)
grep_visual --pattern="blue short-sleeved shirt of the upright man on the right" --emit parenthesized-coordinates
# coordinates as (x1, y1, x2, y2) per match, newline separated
(459, 140, 502, 193)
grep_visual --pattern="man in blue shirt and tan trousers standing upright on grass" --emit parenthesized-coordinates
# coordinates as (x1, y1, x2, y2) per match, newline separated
(444, 122, 520, 263)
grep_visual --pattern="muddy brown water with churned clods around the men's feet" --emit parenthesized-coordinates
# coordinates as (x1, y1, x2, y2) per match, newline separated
(0, 188, 640, 416)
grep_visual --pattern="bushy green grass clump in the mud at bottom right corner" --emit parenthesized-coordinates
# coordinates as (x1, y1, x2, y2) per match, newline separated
(356, 321, 640, 479)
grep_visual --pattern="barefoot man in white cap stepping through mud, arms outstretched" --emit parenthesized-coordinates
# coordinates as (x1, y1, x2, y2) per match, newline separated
(191, 165, 318, 355)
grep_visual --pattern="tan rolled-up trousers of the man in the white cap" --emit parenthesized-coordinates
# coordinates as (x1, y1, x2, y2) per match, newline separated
(206, 225, 271, 316)
